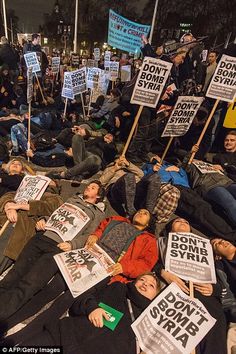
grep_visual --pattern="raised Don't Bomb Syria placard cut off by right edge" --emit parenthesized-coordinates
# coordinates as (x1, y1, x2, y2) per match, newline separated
(206, 54, 236, 102)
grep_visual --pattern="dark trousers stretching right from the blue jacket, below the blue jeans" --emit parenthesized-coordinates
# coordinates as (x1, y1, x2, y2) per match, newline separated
(176, 186, 236, 241)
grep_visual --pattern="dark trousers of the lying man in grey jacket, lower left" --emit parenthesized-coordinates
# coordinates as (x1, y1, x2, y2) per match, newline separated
(0, 233, 61, 320)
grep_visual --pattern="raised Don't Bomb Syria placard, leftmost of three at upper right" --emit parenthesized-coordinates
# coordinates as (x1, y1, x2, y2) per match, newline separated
(130, 57, 172, 108)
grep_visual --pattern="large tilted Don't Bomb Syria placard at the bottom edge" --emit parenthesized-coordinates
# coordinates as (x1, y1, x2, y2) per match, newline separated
(131, 283, 216, 354)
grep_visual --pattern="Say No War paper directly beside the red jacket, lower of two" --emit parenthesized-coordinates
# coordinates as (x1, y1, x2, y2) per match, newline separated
(54, 244, 114, 297)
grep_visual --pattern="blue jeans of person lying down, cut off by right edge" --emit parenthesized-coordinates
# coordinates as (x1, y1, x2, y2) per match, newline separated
(206, 183, 236, 226)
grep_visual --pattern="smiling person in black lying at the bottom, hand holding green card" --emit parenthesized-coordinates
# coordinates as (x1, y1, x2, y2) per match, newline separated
(2, 272, 160, 354)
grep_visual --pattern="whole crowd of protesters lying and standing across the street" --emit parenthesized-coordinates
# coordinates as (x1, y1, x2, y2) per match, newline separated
(0, 33, 236, 354)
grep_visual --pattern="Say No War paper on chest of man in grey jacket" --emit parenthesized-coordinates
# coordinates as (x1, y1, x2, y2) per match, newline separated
(45, 203, 90, 241)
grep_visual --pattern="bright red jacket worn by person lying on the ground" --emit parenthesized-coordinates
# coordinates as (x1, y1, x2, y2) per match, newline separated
(93, 216, 158, 283)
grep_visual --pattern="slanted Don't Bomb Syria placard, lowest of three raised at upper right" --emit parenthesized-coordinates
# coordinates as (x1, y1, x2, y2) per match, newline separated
(161, 96, 204, 137)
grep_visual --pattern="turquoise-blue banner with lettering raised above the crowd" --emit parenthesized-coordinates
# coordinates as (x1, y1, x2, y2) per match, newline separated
(107, 10, 151, 53)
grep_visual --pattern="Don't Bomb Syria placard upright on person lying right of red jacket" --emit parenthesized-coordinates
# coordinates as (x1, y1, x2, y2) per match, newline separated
(165, 233, 216, 284)
